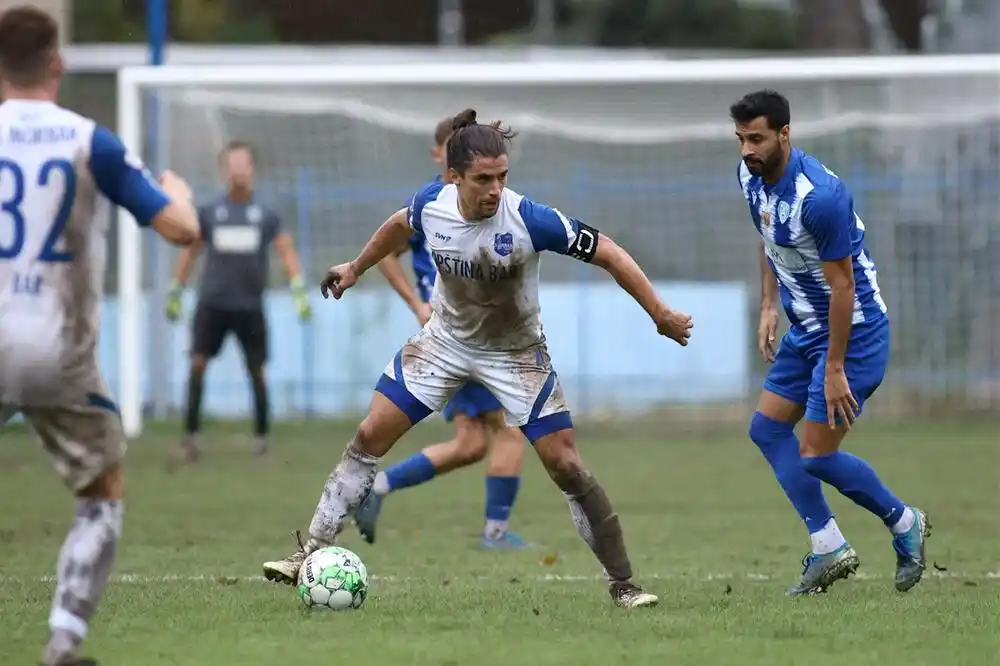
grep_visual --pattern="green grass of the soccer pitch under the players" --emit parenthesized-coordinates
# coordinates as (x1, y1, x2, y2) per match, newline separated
(0, 422, 1000, 666)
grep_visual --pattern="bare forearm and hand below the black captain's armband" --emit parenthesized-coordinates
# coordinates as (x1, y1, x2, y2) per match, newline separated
(591, 232, 694, 346)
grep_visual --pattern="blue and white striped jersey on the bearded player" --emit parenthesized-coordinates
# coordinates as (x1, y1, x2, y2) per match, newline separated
(739, 149, 887, 333)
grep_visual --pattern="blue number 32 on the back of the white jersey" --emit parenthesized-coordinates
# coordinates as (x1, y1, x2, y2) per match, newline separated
(0, 159, 76, 295)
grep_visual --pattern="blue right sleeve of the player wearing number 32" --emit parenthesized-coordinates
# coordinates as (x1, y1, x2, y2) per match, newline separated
(89, 125, 170, 226)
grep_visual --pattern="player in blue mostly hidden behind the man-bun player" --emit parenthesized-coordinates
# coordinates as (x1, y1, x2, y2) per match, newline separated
(354, 117, 527, 549)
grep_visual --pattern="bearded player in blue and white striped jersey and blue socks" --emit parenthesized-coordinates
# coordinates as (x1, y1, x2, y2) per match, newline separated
(730, 90, 930, 596)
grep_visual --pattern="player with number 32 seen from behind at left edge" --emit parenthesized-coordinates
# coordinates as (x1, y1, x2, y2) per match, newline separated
(0, 7, 198, 666)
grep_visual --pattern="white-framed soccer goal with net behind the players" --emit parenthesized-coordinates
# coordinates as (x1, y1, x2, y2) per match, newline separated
(115, 56, 1000, 434)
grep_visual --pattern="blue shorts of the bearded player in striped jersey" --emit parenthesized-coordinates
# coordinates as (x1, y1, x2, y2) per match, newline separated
(764, 319, 889, 423)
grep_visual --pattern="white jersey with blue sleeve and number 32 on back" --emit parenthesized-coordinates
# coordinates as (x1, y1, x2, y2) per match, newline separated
(0, 99, 169, 407)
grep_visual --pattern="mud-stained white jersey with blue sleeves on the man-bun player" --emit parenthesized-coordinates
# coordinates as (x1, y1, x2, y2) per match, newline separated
(407, 182, 580, 351)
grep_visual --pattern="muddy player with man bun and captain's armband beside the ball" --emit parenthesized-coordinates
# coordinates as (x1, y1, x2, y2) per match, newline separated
(264, 109, 692, 608)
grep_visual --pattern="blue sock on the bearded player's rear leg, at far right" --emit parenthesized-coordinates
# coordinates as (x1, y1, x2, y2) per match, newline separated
(803, 451, 906, 527)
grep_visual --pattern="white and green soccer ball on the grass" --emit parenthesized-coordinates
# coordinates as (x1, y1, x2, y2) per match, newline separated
(296, 546, 368, 610)
